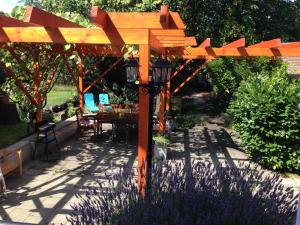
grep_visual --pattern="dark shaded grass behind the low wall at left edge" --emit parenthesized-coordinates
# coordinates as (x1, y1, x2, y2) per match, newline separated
(0, 122, 31, 148)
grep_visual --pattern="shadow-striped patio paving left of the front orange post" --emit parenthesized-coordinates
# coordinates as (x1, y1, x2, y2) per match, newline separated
(0, 127, 137, 224)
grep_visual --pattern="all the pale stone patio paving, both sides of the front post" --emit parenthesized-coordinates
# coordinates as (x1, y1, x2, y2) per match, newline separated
(0, 124, 300, 224)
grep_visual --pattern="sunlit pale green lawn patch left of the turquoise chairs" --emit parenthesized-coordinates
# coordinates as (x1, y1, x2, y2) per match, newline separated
(46, 85, 77, 107)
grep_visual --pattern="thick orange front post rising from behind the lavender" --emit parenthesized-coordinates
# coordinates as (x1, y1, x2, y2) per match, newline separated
(138, 45, 152, 196)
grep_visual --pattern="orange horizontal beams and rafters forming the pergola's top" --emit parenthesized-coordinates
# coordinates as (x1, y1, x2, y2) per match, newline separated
(0, 6, 300, 59)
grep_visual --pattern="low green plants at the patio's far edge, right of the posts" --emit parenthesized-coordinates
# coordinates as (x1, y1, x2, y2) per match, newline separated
(175, 113, 204, 129)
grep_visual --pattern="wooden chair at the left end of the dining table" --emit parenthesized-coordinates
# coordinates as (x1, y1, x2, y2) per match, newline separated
(76, 109, 98, 137)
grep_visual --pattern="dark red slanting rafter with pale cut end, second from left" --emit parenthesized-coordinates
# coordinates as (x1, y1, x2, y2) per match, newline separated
(24, 6, 83, 28)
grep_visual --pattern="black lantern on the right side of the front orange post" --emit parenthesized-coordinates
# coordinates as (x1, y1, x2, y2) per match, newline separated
(152, 57, 172, 85)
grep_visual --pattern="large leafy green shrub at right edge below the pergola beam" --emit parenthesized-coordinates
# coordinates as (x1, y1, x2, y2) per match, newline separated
(229, 66, 300, 172)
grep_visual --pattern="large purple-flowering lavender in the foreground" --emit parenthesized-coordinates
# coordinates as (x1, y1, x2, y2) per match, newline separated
(68, 161, 297, 225)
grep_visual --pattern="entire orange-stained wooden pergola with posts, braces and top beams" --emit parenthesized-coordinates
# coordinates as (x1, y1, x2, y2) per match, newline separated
(0, 5, 300, 194)
